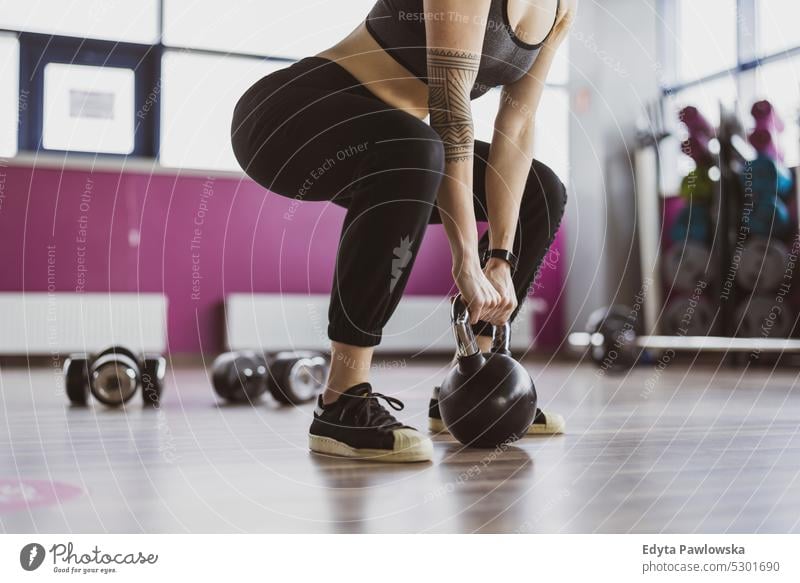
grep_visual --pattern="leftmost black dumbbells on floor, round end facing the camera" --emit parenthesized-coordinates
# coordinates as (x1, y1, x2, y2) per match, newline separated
(64, 346, 166, 407)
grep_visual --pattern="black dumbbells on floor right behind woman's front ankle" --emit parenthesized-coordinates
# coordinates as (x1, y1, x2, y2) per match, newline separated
(212, 350, 328, 405)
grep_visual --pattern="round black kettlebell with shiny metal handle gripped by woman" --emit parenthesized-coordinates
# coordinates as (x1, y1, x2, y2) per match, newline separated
(439, 295, 536, 448)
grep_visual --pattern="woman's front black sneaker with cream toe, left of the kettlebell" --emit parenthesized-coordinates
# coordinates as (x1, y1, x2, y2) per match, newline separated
(308, 383, 433, 462)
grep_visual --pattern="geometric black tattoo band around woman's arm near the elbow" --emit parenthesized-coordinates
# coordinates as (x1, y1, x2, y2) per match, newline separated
(428, 48, 481, 162)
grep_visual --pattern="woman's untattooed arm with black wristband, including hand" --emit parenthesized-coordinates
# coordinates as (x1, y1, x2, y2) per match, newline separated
(486, 0, 577, 317)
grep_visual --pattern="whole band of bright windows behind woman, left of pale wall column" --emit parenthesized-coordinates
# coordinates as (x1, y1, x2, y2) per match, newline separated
(0, 0, 569, 173)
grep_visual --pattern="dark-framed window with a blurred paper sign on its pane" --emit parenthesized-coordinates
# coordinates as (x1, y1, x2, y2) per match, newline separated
(19, 33, 159, 157)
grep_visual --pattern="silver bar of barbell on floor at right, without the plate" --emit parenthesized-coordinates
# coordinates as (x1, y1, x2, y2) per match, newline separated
(567, 332, 800, 352)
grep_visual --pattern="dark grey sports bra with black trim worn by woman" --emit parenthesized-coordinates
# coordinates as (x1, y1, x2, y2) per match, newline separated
(366, 0, 560, 99)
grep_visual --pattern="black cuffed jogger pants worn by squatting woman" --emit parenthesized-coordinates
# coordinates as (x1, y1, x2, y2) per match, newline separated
(231, 57, 566, 346)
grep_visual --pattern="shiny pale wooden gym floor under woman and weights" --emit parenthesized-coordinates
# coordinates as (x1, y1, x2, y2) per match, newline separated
(0, 361, 800, 533)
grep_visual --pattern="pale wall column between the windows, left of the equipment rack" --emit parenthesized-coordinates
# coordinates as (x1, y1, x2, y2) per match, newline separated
(566, 0, 662, 330)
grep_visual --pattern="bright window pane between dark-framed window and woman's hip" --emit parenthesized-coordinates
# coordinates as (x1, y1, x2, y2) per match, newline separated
(160, 51, 286, 170)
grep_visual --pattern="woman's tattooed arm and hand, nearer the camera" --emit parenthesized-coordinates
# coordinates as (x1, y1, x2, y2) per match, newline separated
(423, 0, 499, 322)
